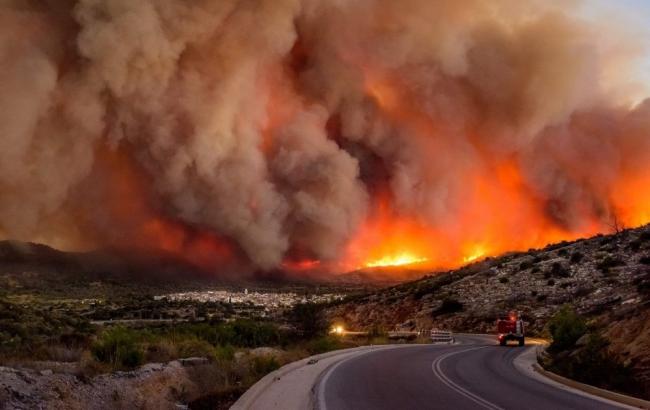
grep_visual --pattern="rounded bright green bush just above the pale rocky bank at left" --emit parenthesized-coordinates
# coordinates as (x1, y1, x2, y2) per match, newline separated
(91, 327, 144, 368)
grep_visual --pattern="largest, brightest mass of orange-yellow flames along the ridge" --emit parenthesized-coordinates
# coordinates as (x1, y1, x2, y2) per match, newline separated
(344, 147, 606, 270)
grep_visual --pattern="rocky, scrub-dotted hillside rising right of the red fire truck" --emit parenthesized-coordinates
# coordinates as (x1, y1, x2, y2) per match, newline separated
(329, 225, 650, 388)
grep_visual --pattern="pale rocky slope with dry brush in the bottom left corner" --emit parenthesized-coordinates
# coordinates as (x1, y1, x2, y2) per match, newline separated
(0, 347, 286, 410)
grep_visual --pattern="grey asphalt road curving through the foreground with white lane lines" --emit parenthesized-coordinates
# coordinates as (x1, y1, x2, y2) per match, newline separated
(316, 336, 621, 410)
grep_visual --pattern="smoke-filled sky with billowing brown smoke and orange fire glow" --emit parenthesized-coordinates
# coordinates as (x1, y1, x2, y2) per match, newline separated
(0, 0, 650, 272)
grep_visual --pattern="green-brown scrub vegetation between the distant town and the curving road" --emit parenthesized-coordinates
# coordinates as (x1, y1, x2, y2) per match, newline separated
(0, 299, 364, 408)
